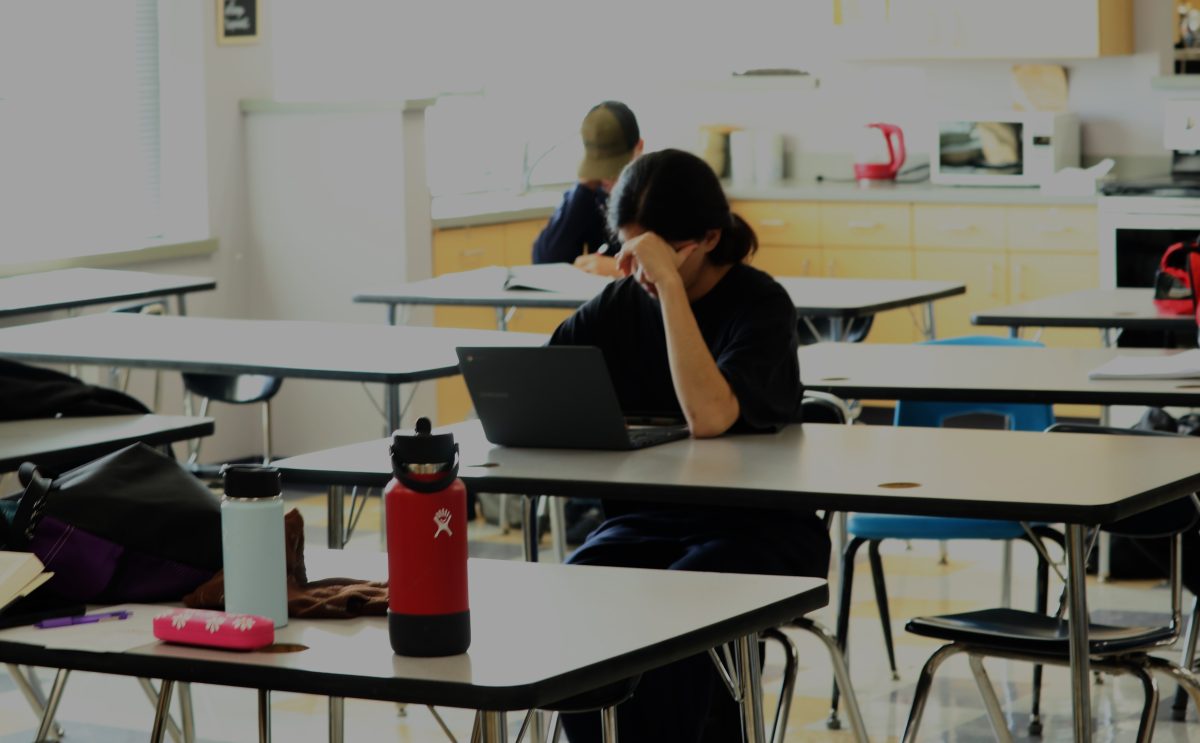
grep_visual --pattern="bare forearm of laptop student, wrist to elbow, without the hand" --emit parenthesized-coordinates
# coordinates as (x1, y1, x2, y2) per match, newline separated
(659, 283, 740, 438)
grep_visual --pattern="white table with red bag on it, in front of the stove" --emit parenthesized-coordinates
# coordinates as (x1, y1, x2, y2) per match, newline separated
(971, 288, 1196, 346)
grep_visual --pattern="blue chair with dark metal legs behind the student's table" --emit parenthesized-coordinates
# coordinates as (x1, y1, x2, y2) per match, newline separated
(833, 336, 1062, 735)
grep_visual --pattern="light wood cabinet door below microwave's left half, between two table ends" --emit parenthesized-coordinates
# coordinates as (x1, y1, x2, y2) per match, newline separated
(916, 250, 1008, 338)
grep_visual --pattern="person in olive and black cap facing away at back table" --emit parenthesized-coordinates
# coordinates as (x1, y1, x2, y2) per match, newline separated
(533, 101, 642, 276)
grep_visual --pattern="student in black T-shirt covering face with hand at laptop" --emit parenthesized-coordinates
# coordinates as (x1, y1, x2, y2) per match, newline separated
(551, 150, 829, 743)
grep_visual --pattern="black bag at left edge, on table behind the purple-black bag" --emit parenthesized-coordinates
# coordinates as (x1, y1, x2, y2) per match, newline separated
(0, 359, 150, 420)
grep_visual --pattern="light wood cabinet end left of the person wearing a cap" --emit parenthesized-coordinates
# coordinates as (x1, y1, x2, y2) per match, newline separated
(433, 220, 552, 425)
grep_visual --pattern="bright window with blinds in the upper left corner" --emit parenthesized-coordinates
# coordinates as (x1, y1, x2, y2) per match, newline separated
(0, 0, 206, 263)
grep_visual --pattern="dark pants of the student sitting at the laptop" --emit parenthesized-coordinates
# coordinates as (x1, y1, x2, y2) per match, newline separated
(563, 509, 829, 743)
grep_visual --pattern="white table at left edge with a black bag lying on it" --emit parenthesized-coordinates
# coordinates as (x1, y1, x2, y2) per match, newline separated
(0, 415, 212, 472)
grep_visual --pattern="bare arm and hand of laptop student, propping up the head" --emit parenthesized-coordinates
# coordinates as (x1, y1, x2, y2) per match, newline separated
(618, 233, 740, 438)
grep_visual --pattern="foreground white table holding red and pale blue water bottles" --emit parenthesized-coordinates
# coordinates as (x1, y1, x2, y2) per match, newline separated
(0, 550, 828, 743)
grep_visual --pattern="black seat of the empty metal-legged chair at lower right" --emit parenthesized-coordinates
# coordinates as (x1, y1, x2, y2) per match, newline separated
(905, 609, 1176, 657)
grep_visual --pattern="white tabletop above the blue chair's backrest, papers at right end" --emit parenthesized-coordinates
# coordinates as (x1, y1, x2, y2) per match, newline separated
(799, 343, 1200, 406)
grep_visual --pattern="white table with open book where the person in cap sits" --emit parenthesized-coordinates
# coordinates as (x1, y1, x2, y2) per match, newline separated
(354, 264, 966, 340)
